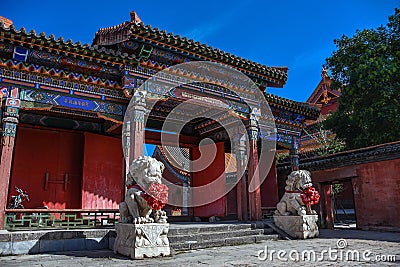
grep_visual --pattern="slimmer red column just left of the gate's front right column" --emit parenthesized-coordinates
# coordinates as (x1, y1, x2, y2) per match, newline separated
(233, 134, 249, 221)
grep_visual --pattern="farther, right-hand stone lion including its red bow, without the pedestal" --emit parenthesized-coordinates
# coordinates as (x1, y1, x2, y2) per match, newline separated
(275, 170, 319, 216)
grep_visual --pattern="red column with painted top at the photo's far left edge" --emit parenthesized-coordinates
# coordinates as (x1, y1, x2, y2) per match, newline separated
(0, 88, 20, 229)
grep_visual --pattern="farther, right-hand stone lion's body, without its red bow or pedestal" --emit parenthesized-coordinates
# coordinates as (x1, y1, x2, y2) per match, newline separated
(275, 170, 316, 215)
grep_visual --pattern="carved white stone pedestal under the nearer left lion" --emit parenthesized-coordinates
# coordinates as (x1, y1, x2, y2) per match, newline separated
(114, 223, 171, 259)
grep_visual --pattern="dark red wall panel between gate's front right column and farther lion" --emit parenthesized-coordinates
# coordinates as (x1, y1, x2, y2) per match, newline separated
(260, 161, 279, 208)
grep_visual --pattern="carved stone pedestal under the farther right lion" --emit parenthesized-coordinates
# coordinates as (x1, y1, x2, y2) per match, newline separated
(274, 215, 319, 239)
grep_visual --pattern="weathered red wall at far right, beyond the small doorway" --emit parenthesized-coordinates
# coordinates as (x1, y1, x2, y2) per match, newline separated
(353, 159, 400, 228)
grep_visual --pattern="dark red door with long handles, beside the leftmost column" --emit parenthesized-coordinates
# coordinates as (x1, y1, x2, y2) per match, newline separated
(9, 125, 83, 209)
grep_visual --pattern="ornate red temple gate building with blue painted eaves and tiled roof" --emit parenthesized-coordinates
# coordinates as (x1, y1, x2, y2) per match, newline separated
(0, 12, 318, 227)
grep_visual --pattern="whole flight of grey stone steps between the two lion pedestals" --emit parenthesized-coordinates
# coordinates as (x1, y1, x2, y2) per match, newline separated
(168, 223, 279, 251)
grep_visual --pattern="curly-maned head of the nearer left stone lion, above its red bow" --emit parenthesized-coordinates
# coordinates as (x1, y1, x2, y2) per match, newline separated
(126, 156, 164, 187)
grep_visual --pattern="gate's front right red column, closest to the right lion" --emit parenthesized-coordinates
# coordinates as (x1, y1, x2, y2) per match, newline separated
(247, 119, 262, 221)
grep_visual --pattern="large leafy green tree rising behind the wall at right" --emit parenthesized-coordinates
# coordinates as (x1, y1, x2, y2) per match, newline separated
(325, 8, 400, 148)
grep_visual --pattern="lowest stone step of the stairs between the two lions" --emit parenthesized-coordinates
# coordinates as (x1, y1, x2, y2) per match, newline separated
(170, 234, 279, 251)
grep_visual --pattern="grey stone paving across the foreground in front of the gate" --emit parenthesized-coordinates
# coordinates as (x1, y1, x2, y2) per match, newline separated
(0, 230, 400, 267)
